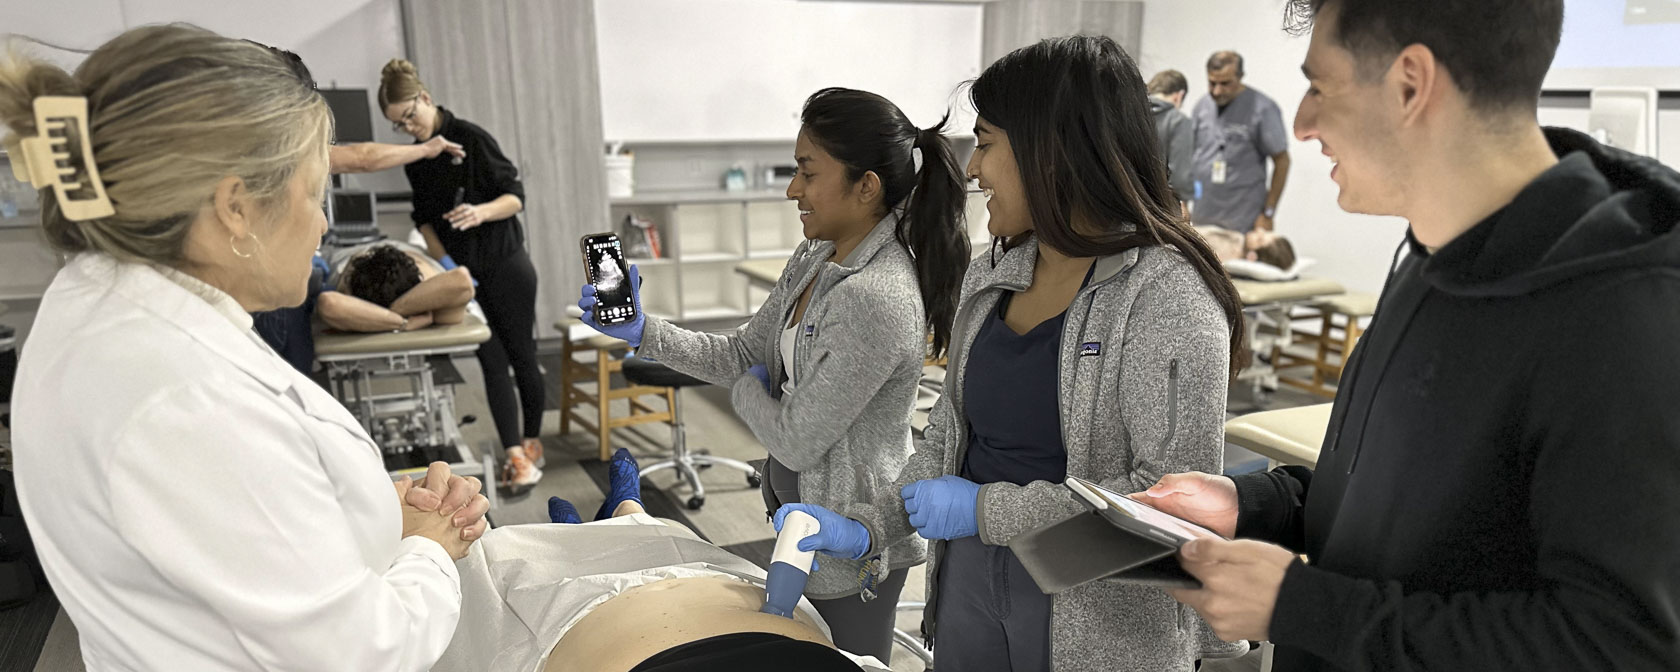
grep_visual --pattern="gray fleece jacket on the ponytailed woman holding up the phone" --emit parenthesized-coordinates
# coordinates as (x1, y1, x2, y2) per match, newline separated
(637, 215, 927, 600)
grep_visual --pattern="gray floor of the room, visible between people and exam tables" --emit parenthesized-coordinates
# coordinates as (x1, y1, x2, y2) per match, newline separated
(19, 341, 1324, 672)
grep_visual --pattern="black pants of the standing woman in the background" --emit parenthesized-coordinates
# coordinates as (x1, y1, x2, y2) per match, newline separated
(469, 250, 546, 449)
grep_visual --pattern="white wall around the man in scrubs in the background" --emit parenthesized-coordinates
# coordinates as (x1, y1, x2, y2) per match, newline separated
(1137, 0, 1406, 294)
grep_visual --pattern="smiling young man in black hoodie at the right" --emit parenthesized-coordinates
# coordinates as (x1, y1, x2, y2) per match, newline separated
(1139, 0, 1680, 672)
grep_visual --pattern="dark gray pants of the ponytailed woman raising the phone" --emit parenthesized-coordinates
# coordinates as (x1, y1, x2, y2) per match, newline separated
(761, 457, 909, 664)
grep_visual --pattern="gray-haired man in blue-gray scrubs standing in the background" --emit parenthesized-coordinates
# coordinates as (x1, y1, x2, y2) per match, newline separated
(1191, 52, 1289, 232)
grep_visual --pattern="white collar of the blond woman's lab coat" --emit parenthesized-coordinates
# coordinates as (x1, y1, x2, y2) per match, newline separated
(64, 252, 292, 393)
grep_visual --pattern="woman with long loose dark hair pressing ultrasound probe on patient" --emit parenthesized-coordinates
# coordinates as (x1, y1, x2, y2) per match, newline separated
(776, 37, 1243, 672)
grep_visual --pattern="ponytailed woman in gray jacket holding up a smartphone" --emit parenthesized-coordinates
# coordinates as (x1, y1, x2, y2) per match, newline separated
(578, 89, 969, 660)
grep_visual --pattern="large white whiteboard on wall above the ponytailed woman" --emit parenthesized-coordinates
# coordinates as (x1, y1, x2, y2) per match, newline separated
(595, 0, 981, 141)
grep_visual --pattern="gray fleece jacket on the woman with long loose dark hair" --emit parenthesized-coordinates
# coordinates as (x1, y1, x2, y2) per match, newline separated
(847, 239, 1245, 672)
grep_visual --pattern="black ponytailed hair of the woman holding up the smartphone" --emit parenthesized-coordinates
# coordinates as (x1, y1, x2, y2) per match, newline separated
(800, 87, 969, 356)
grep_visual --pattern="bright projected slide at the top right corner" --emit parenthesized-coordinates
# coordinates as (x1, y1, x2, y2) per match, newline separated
(1546, 0, 1680, 89)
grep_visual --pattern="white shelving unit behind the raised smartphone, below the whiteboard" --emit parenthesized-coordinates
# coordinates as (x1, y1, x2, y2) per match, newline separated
(612, 190, 991, 321)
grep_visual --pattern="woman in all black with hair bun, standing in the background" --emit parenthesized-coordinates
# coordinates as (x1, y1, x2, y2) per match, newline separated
(380, 59, 544, 489)
